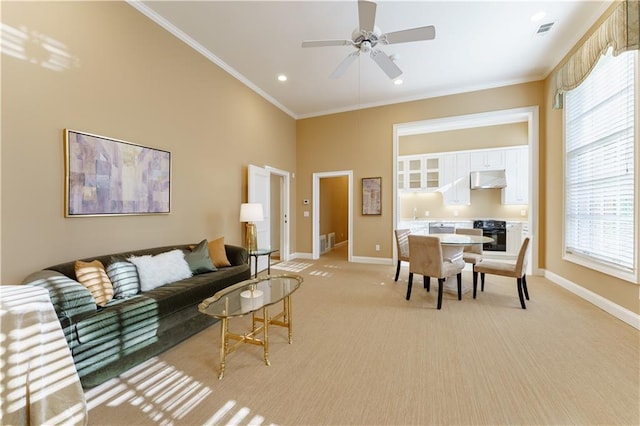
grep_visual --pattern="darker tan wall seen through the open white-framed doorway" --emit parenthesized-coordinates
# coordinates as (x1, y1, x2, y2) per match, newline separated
(320, 176, 349, 244)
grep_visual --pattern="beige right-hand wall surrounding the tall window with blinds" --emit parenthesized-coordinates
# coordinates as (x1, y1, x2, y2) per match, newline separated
(540, 5, 640, 314)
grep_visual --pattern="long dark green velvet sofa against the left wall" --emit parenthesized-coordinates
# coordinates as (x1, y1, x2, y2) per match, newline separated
(23, 244, 251, 388)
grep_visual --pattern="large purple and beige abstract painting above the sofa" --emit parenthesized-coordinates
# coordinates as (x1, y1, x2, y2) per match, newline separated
(64, 129, 171, 217)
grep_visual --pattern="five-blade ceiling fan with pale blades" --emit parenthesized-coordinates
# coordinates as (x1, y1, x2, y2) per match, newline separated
(302, 0, 436, 79)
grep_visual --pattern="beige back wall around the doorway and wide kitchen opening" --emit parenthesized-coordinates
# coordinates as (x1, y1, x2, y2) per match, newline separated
(297, 82, 544, 260)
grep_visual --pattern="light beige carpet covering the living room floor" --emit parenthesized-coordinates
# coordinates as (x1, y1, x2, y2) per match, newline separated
(87, 246, 640, 425)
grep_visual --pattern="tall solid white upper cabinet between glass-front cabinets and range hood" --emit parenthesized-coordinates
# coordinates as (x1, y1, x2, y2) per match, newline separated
(440, 153, 471, 206)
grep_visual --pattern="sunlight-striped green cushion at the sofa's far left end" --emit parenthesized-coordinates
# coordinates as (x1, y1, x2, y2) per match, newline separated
(22, 269, 97, 326)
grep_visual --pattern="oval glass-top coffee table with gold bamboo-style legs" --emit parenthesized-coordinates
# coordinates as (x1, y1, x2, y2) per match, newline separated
(198, 274, 303, 379)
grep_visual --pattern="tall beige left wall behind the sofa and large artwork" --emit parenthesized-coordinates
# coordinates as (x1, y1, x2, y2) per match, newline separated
(1, 2, 296, 284)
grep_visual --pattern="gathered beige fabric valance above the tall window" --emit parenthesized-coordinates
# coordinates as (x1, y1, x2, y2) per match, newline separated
(553, 0, 640, 108)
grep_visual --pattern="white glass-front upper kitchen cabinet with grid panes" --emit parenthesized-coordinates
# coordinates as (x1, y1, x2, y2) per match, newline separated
(397, 155, 440, 191)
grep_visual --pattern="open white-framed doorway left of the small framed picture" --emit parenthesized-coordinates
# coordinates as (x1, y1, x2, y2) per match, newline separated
(312, 170, 353, 262)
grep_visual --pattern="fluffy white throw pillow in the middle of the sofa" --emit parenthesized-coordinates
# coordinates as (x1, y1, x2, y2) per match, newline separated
(127, 250, 191, 291)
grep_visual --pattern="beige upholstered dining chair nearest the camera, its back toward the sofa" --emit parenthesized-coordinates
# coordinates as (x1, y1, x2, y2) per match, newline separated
(407, 235, 464, 309)
